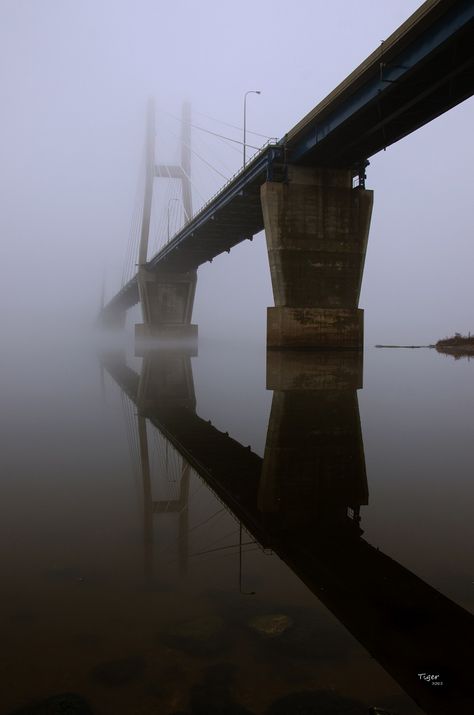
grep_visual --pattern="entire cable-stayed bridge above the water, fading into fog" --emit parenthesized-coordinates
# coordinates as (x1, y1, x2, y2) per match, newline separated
(101, 0, 474, 349)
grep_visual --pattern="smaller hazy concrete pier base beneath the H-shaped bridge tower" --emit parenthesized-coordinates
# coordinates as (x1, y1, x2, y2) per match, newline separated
(135, 268, 198, 340)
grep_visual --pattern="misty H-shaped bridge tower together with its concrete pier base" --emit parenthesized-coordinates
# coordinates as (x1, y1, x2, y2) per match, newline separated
(135, 101, 197, 339)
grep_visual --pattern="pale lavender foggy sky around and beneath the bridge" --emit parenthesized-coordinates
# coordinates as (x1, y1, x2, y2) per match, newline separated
(0, 0, 474, 343)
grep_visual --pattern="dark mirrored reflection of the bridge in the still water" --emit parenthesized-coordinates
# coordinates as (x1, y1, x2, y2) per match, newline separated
(102, 350, 473, 715)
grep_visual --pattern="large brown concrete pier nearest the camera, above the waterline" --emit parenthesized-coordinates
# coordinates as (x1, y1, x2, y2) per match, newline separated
(261, 166, 373, 349)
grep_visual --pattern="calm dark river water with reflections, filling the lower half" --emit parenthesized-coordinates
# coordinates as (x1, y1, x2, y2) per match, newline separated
(0, 336, 474, 715)
